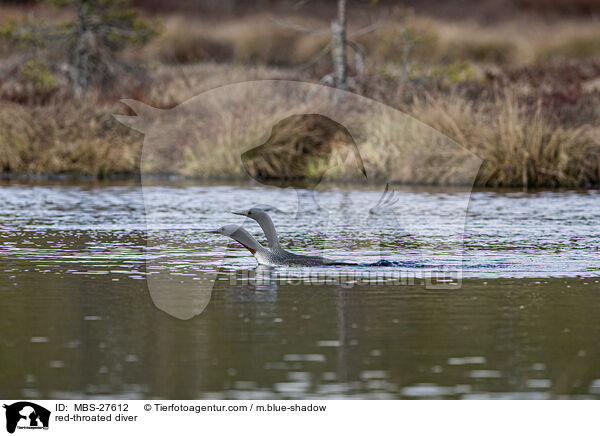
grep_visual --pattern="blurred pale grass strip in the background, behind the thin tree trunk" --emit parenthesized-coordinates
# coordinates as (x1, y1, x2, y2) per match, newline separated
(147, 14, 600, 68)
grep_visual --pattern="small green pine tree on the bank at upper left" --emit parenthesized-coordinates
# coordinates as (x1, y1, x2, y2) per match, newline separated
(0, 0, 154, 96)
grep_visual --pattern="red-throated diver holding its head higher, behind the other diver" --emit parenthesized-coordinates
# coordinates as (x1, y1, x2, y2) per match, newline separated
(233, 207, 355, 266)
